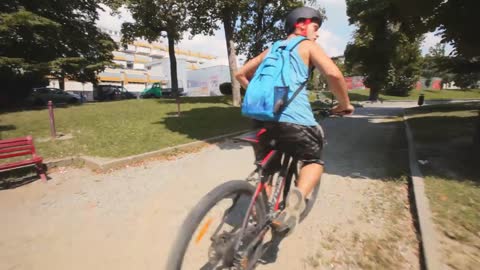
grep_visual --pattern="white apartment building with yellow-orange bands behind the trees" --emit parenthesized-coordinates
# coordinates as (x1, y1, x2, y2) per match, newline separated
(50, 29, 229, 99)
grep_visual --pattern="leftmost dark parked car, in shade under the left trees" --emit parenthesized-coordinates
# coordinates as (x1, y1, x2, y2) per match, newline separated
(27, 87, 81, 106)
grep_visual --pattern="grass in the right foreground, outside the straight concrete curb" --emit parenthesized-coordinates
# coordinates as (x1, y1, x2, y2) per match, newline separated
(407, 102, 480, 269)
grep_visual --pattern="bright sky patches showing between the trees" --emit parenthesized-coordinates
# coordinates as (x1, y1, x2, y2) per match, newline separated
(97, 0, 440, 65)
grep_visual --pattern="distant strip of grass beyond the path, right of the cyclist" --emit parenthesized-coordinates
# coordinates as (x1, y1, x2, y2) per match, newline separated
(314, 89, 480, 101)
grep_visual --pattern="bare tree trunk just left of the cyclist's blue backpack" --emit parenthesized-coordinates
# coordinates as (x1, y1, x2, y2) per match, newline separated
(223, 14, 241, 107)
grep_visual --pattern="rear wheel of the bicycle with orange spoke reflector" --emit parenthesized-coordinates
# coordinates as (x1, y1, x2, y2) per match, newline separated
(167, 180, 266, 270)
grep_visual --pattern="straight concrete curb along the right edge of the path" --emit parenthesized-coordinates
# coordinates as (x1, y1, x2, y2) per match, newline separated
(403, 111, 444, 270)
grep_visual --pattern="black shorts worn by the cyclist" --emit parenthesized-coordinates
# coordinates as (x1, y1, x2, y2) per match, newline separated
(254, 121, 324, 165)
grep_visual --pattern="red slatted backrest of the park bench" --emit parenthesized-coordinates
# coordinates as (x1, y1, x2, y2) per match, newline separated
(0, 136, 37, 159)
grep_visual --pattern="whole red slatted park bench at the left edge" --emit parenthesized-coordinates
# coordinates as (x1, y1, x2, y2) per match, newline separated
(0, 136, 47, 182)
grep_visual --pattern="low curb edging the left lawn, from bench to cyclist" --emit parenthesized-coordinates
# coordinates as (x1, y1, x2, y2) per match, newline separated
(44, 129, 250, 172)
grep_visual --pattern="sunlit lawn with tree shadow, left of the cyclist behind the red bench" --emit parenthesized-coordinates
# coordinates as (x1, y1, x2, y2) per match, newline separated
(0, 97, 249, 158)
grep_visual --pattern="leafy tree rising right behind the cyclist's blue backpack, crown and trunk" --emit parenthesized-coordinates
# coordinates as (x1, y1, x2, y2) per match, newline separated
(187, 0, 302, 106)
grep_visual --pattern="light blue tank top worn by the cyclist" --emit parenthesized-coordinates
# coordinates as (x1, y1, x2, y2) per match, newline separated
(278, 37, 318, 126)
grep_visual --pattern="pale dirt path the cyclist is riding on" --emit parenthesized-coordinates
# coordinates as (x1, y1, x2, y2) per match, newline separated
(0, 104, 419, 269)
